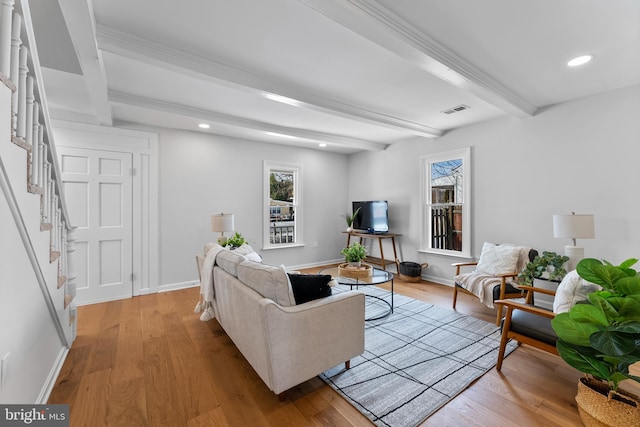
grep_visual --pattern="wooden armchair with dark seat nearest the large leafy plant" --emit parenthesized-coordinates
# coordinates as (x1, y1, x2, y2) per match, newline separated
(496, 286, 558, 371)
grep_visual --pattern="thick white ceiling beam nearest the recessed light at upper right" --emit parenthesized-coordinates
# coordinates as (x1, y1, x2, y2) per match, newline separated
(298, 0, 538, 118)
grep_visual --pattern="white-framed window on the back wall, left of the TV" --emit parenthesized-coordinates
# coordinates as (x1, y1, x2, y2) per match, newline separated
(263, 161, 302, 249)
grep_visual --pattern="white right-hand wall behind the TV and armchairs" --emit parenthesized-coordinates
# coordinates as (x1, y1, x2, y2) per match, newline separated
(349, 86, 640, 283)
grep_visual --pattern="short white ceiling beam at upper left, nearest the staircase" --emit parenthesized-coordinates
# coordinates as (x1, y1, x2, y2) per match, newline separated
(58, 0, 113, 126)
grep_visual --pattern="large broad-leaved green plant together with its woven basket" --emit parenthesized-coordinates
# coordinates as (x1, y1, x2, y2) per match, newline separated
(551, 258, 640, 426)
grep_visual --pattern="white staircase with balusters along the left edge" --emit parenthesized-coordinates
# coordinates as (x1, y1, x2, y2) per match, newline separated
(0, 0, 76, 357)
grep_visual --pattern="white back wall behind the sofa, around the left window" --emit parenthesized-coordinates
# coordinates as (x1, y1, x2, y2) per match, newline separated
(158, 130, 347, 287)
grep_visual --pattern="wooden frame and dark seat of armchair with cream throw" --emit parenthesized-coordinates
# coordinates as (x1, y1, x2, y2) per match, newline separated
(451, 249, 538, 325)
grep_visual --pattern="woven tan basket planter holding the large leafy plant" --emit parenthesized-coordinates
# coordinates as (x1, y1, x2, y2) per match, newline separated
(576, 378, 640, 427)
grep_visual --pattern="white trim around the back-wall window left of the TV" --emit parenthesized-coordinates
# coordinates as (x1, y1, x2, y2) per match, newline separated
(262, 160, 304, 250)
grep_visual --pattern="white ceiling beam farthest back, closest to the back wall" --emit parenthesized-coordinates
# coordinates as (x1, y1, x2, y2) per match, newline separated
(109, 90, 388, 151)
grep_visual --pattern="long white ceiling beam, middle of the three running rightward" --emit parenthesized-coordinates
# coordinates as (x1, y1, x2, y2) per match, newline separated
(97, 25, 444, 138)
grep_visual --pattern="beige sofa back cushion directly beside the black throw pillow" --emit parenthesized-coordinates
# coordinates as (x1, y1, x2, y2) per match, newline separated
(237, 261, 296, 307)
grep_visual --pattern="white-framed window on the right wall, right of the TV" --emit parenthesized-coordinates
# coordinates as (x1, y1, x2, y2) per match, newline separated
(421, 147, 471, 257)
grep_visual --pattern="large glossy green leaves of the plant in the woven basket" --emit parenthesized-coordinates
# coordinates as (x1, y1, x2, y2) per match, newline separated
(551, 258, 640, 391)
